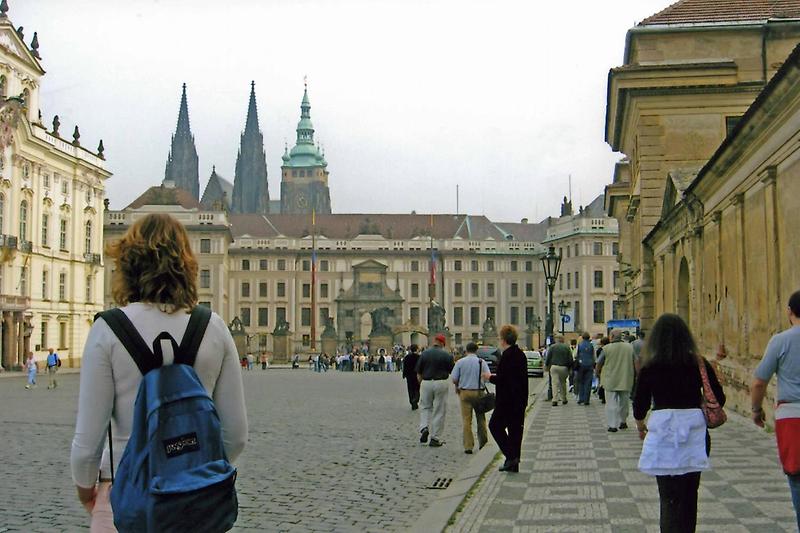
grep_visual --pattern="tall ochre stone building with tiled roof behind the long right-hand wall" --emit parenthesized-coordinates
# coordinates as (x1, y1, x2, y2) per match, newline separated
(606, 0, 800, 328)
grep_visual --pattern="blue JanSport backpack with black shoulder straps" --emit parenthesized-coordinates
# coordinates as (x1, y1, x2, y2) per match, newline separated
(98, 305, 239, 533)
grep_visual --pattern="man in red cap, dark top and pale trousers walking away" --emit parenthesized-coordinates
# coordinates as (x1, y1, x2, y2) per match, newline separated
(416, 333, 455, 448)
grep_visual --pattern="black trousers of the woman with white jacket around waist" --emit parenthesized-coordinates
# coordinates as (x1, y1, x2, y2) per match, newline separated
(656, 472, 700, 533)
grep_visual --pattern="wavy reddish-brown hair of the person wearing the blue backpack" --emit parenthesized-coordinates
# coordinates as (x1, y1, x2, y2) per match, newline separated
(106, 214, 197, 313)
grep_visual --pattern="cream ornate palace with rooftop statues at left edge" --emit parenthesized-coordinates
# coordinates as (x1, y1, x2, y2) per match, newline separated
(0, 2, 111, 369)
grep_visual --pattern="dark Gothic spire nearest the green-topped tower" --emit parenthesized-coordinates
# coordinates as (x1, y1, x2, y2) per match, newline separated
(231, 82, 269, 214)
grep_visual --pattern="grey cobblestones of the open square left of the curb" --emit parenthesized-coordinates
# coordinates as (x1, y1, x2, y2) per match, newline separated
(0, 369, 482, 532)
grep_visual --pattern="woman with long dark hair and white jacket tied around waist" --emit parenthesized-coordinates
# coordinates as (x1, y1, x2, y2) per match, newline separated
(633, 314, 725, 533)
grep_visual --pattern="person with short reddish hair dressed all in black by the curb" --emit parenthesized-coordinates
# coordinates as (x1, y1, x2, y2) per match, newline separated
(489, 325, 528, 472)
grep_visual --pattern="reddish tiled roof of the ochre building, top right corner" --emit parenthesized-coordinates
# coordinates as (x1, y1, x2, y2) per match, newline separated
(639, 0, 800, 26)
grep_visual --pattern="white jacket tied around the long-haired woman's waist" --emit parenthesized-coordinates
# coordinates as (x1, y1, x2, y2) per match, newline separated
(639, 409, 711, 476)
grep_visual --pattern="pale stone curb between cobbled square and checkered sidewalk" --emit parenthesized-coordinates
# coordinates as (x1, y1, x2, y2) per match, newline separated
(408, 379, 547, 533)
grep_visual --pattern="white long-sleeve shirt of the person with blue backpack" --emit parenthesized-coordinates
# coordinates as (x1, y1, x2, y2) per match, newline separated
(70, 303, 247, 488)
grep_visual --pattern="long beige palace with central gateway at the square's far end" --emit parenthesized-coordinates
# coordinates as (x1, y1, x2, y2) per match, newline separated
(105, 186, 616, 359)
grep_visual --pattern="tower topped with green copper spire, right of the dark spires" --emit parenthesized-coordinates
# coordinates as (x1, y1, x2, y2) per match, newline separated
(281, 81, 331, 214)
